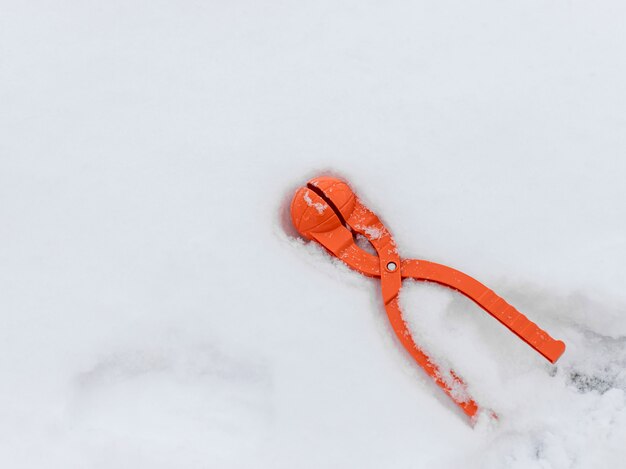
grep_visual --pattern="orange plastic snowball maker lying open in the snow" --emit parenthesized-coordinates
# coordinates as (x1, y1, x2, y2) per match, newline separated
(291, 177, 565, 417)
